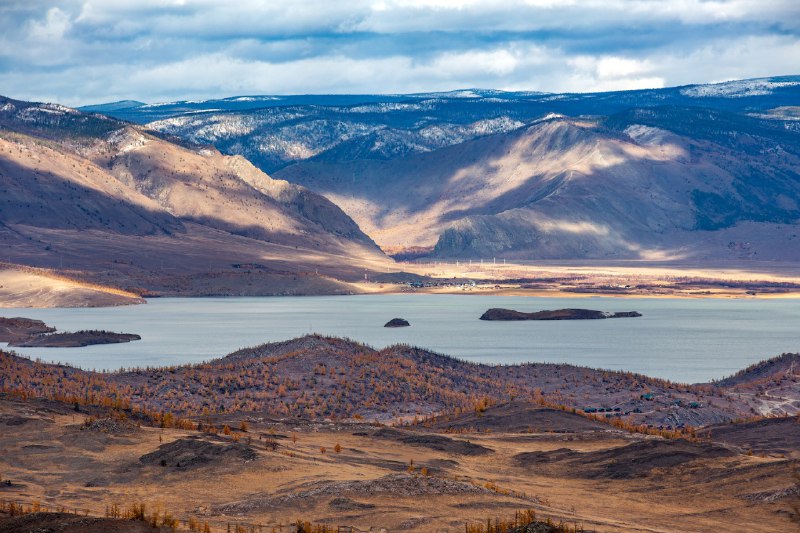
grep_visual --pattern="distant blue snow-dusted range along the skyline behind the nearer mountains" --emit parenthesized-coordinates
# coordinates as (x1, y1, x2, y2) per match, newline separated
(82, 76, 800, 172)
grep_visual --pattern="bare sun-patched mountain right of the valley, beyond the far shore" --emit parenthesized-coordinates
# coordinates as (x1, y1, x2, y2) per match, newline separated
(277, 108, 800, 259)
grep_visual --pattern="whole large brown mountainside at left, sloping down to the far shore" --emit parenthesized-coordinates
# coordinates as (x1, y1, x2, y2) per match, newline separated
(0, 93, 386, 294)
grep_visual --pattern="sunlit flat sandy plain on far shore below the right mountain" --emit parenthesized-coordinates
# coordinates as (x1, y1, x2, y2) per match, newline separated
(355, 261, 800, 299)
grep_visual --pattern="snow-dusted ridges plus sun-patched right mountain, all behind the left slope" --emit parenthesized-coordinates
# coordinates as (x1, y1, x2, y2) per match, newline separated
(79, 76, 800, 261)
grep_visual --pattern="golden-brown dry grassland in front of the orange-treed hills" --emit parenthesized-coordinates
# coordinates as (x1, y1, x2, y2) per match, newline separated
(0, 375, 800, 533)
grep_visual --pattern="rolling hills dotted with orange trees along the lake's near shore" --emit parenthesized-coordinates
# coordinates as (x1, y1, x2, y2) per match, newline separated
(0, 335, 800, 429)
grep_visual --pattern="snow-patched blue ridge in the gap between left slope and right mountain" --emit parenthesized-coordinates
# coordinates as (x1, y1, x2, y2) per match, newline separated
(147, 107, 527, 172)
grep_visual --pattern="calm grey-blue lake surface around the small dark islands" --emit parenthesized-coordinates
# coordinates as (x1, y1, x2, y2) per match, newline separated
(0, 294, 800, 382)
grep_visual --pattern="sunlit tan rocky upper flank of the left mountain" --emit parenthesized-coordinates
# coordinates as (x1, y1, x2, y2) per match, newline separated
(94, 127, 374, 247)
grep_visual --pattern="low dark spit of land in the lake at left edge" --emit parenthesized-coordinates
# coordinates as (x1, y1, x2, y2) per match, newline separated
(0, 317, 141, 348)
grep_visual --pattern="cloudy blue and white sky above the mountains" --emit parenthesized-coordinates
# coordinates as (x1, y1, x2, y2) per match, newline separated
(0, 0, 800, 106)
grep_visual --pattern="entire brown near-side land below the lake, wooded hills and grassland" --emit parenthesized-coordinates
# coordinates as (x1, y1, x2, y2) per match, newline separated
(0, 332, 800, 533)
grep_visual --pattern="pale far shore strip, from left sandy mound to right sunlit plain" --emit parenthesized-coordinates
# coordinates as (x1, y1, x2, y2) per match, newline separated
(0, 262, 800, 308)
